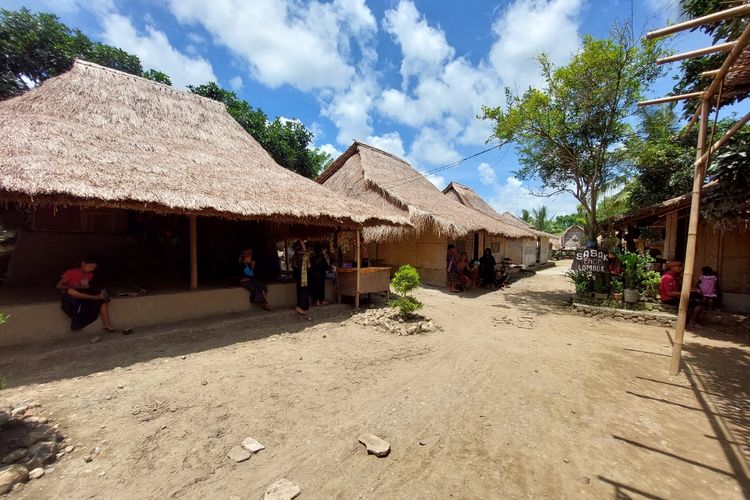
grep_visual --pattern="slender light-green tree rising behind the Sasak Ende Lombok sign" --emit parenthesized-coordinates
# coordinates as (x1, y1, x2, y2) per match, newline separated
(483, 26, 661, 238)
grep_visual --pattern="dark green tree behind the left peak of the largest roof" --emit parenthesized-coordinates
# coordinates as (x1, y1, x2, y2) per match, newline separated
(0, 8, 152, 99)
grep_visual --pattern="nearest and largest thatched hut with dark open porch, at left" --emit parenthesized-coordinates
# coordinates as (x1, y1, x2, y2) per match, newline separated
(0, 61, 408, 344)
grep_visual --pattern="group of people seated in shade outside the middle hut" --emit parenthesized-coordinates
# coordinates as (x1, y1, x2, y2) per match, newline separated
(445, 244, 512, 292)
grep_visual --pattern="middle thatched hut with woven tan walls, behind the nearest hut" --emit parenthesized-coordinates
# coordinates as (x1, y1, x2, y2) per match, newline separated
(317, 142, 528, 286)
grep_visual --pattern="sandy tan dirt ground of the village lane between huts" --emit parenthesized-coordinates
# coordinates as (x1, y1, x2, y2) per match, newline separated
(0, 264, 750, 499)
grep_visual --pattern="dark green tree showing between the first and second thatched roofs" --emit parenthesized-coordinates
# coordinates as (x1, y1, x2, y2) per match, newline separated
(188, 82, 330, 179)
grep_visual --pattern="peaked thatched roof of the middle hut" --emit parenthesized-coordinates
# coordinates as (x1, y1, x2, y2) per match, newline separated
(317, 142, 528, 241)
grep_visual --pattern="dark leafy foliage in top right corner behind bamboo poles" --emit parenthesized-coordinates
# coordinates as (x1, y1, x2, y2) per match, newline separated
(674, 0, 747, 117)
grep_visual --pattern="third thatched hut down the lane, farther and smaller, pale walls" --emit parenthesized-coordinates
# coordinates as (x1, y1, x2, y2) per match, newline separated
(443, 182, 554, 268)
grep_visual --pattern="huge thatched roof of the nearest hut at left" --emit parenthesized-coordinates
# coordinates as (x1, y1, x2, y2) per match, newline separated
(0, 61, 408, 227)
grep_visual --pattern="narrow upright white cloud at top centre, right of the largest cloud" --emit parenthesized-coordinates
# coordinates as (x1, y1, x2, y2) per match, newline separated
(383, 0, 455, 89)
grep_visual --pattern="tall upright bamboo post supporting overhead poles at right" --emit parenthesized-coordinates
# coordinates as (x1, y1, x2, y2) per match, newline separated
(669, 99, 711, 375)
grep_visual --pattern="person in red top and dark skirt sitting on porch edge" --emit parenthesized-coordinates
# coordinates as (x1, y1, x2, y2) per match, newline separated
(57, 257, 115, 332)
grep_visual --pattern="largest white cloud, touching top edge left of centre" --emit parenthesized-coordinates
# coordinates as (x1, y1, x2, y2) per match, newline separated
(169, 0, 377, 90)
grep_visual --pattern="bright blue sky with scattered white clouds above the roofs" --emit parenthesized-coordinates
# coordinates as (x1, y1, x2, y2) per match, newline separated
(3, 0, 736, 214)
